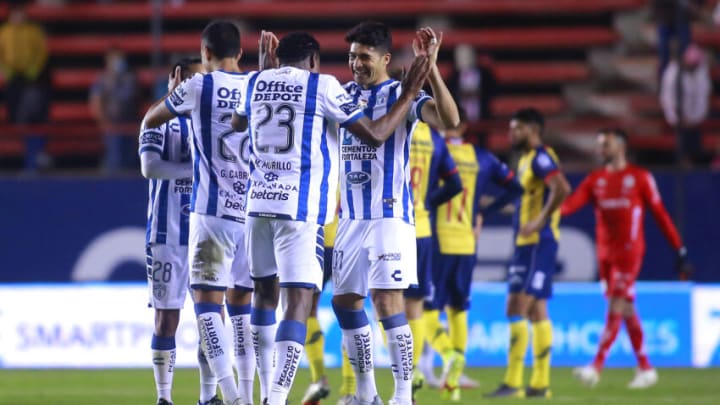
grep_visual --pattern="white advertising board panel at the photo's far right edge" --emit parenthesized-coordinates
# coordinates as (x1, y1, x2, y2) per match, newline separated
(692, 287, 720, 367)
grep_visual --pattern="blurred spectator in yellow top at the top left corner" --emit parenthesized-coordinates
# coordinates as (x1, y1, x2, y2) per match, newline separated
(0, 2, 50, 171)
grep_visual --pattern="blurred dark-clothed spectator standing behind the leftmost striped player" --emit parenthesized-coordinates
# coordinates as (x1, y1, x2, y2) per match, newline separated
(90, 49, 139, 171)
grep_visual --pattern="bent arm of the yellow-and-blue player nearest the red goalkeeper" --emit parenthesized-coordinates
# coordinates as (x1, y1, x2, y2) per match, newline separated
(520, 152, 572, 236)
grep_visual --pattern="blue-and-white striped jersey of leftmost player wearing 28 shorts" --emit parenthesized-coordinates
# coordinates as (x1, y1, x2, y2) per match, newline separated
(138, 116, 192, 246)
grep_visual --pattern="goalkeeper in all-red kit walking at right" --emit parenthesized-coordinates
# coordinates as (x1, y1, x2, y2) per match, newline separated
(561, 129, 690, 389)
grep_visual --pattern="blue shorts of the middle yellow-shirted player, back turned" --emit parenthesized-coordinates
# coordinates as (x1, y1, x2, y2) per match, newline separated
(425, 254, 477, 310)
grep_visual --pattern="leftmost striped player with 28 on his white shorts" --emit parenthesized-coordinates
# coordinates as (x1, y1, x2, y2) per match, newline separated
(138, 58, 222, 405)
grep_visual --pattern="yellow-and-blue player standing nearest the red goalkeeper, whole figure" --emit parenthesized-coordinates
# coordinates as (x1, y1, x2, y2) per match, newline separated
(488, 108, 570, 398)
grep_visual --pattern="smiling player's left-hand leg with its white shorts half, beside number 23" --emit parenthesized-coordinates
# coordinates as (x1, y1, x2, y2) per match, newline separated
(332, 218, 377, 404)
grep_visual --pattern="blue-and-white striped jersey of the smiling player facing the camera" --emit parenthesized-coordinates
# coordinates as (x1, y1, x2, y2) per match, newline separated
(340, 80, 430, 224)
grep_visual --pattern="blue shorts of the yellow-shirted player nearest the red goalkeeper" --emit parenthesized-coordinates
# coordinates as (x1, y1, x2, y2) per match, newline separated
(508, 239, 558, 299)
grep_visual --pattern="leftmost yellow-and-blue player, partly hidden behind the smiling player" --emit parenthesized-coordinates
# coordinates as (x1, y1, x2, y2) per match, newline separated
(405, 122, 462, 395)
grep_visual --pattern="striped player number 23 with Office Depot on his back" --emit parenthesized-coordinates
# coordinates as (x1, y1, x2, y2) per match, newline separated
(237, 32, 430, 405)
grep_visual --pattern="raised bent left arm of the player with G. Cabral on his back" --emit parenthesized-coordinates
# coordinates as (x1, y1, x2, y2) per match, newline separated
(142, 67, 197, 128)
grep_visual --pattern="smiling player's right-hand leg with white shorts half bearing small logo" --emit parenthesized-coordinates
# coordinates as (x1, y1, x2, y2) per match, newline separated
(369, 218, 417, 405)
